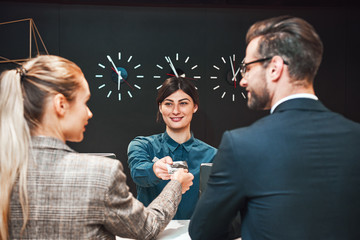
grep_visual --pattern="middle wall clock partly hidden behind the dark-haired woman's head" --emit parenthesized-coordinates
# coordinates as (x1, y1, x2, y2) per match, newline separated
(153, 53, 201, 89)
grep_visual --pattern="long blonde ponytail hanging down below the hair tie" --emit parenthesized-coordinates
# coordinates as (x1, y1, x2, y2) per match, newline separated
(0, 70, 31, 240)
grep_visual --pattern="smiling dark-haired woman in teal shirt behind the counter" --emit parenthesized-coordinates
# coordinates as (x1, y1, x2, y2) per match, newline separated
(128, 77, 217, 219)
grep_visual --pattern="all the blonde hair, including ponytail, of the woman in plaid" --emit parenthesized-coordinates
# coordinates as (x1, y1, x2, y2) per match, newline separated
(0, 55, 83, 240)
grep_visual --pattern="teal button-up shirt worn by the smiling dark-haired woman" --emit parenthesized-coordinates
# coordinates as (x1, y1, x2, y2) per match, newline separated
(128, 132, 217, 219)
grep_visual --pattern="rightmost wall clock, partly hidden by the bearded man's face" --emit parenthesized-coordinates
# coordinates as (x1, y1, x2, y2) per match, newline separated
(209, 54, 246, 102)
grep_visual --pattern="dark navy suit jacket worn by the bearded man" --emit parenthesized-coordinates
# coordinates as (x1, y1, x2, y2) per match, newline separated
(189, 98, 360, 240)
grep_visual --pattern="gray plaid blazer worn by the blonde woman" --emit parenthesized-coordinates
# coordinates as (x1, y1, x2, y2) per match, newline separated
(9, 137, 181, 239)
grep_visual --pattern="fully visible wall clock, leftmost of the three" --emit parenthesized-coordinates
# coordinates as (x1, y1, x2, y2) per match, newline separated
(95, 52, 144, 101)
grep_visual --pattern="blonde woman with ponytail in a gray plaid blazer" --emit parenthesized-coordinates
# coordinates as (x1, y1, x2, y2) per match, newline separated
(0, 56, 193, 240)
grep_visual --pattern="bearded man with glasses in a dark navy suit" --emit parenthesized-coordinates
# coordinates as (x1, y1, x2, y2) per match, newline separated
(189, 16, 360, 240)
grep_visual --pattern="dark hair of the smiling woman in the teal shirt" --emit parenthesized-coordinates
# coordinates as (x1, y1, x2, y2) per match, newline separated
(156, 77, 199, 121)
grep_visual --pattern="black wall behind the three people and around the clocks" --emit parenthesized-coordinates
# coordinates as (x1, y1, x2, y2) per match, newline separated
(0, 0, 360, 195)
